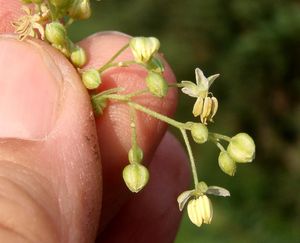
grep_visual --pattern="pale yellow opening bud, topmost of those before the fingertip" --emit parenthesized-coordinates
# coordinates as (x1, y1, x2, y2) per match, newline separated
(129, 37, 160, 63)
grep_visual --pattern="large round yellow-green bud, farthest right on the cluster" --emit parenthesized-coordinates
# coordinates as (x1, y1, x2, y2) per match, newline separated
(227, 133, 255, 163)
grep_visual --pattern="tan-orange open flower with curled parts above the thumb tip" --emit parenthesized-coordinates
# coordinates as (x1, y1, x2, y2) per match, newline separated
(12, 4, 50, 40)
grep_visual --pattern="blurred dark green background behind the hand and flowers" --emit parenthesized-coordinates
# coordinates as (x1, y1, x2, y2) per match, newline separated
(72, 0, 300, 243)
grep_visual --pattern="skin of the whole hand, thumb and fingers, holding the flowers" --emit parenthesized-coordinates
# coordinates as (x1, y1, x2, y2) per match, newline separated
(0, 0, 189, 243)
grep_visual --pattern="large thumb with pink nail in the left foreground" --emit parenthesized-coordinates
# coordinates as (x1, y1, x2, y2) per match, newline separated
(0, 36, 101, 243)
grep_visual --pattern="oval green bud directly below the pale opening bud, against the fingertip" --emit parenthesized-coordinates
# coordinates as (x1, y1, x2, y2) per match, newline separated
(146, 72, 168, 98)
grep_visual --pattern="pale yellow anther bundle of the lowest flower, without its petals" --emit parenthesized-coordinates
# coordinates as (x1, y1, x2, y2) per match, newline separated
(187, 195, 213, 227)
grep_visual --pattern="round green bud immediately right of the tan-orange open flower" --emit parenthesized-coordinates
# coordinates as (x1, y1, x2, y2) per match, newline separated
(45, 22, 67, 46)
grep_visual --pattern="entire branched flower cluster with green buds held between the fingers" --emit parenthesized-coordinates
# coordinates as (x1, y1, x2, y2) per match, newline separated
(12, 0, 255, 227)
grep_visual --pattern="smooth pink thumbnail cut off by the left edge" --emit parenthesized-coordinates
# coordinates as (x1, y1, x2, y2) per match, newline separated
(0, 37, 62, 140)
